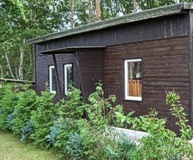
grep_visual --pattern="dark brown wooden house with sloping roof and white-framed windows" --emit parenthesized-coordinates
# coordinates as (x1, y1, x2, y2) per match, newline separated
(29, 4, 193, 129)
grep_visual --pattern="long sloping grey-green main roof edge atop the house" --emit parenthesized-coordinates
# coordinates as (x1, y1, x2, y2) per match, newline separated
(28, 3, 193, 44)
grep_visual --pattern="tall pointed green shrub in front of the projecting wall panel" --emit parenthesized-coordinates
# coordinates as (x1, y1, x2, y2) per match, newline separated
(80, 83, 122, 159)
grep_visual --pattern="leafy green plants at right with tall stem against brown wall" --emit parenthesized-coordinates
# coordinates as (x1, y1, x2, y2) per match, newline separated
(116, 92, 193, 159)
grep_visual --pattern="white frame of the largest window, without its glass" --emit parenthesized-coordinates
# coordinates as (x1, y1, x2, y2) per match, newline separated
(124, 58, 142, 101)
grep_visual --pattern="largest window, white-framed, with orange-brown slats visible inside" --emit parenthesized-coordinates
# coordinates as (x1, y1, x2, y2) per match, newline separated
(124, 59, 142, 101)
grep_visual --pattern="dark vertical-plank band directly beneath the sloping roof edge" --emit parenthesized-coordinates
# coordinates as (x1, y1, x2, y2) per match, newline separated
(37, 14, 189, 52)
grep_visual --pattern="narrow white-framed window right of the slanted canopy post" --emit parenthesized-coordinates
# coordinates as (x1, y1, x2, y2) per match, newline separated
(64, 64, 73, 95)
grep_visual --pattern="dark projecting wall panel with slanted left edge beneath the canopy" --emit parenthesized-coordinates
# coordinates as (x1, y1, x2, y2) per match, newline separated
(77, 49, 104, 99)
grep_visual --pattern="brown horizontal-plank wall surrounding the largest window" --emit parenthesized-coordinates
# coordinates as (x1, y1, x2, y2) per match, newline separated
(104, 37, 190, 132)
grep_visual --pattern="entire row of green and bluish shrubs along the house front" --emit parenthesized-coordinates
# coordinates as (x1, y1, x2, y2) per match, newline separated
(0, 83, 193, 160)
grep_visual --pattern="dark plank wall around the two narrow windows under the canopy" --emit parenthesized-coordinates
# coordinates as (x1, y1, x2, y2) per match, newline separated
(36, 54, 80, 99)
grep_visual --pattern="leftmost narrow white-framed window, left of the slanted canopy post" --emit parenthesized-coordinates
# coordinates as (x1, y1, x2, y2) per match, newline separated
(49, 66, 57, 93)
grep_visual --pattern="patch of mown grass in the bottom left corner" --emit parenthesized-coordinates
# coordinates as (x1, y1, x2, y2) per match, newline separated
(0, 132, 57, 160)
